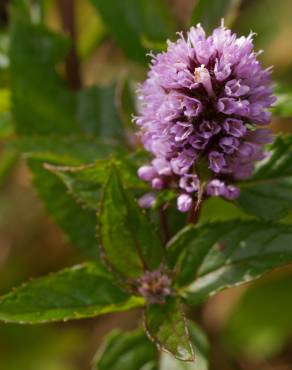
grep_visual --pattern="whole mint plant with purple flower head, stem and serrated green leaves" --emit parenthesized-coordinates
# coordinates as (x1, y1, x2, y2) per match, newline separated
(0, 0, 292, 370)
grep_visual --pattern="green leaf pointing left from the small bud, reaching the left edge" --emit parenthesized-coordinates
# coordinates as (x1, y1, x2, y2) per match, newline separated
(0, 264, 143, 323)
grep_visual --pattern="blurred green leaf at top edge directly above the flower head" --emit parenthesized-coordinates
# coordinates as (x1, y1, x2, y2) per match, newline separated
(191, 0, 241, 33)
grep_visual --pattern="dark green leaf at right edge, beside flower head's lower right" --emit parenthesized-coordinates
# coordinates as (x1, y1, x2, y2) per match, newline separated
(237, 136, 292, 220)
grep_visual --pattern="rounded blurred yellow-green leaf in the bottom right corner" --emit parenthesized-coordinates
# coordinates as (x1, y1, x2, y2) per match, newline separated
(224, 274, 292, 358)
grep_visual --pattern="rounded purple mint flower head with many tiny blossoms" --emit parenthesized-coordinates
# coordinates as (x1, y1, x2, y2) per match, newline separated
(135, 25, 275, 212)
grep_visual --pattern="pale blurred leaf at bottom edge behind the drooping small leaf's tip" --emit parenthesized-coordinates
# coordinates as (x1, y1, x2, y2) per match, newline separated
(159, 322, 209, 370)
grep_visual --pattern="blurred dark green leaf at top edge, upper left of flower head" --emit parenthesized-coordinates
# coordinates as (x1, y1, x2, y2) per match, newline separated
(91, 0, 176, 63)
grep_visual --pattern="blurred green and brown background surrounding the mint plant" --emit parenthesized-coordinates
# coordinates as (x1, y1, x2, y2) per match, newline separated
(0, 0, 292, 370)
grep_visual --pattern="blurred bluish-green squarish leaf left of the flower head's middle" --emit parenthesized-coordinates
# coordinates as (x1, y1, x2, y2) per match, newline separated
(77, 85, 123, 139)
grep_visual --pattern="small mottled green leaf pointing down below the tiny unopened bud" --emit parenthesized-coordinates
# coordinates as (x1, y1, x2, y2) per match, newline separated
(145, 297, 194, 361)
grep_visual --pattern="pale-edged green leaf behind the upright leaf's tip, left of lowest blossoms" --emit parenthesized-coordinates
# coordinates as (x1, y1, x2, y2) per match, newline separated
(45, 160, 148, 210)
